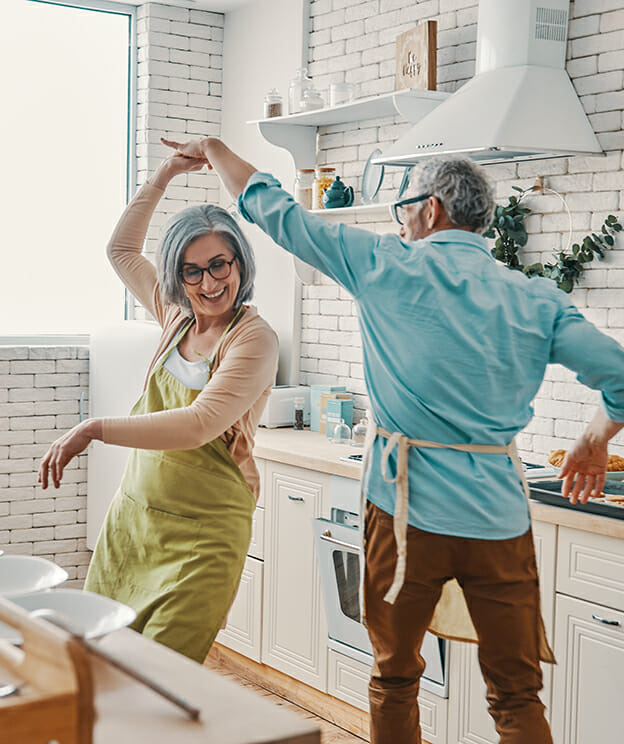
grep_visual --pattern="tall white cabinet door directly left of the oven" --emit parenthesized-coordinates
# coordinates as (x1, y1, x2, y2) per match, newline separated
(262, 461, 329, 692)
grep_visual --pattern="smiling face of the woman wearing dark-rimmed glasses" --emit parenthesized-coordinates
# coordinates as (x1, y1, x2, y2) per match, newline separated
(182, 233, 240, 320)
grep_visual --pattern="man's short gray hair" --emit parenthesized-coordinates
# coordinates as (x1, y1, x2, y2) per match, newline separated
(406, 155, 495, 233)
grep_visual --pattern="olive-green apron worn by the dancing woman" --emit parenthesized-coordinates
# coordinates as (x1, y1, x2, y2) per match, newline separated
(85, 321, 256, 663)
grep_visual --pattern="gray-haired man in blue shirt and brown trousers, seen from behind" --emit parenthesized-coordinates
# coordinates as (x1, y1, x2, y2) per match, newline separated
(166, 138, 624, 744)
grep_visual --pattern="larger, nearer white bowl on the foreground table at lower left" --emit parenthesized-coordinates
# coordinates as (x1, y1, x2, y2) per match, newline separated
(0, 588, 136, 645)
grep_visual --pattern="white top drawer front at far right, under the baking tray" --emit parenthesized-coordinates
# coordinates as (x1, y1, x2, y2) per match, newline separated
(557, 527, 624, 611)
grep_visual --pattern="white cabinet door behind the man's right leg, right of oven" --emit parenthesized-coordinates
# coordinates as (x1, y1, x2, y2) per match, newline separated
(449, 522, 557, 744)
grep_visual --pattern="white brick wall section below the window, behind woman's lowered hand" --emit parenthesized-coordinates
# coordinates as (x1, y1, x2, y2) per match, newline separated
(0, 346, 90, 586)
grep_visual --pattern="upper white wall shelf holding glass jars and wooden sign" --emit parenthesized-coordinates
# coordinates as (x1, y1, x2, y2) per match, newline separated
(248, 89, 450, 168)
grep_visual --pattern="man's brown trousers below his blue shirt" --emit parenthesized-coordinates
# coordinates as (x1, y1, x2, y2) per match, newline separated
(364, 502, 552, 744)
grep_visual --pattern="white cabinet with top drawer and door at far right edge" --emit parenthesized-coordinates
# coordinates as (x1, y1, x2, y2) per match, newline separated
(552, 527, 624, 744)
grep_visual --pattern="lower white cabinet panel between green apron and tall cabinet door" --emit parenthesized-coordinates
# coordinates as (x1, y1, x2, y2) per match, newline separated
(217, 556, 264, 661)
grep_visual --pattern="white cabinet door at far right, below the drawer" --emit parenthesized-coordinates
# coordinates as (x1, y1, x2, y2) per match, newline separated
(553, 595, 624, 744)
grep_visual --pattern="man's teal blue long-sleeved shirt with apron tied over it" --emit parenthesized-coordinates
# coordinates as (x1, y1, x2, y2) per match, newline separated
(239, 173, 624, 540)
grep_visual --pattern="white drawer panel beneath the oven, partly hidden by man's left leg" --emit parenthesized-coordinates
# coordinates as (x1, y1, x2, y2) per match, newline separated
(327, 649, 448, 744)
